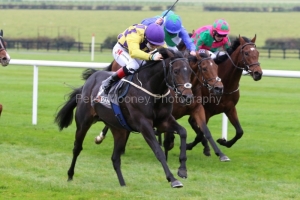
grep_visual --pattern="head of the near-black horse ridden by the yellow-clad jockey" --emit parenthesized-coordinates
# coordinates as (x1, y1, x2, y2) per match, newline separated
(159, 49, 193, 104)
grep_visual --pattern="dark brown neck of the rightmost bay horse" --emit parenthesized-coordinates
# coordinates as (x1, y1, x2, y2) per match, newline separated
(218, 52, 243, 92)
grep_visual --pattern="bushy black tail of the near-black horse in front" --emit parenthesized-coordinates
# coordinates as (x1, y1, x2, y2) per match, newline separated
(54, 87, 82, 131)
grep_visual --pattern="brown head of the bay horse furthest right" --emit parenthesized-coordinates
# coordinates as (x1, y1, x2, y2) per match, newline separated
(231, 35, 263, 81)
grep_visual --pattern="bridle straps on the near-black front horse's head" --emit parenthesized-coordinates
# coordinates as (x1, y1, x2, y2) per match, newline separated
(163, 58, 192, 96)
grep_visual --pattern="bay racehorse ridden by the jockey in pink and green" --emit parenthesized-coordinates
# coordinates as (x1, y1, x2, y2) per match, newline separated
(183, 35, 263, 155)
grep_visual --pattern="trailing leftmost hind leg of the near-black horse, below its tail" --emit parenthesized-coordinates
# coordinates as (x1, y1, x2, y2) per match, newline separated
(68, 108, 93, 181)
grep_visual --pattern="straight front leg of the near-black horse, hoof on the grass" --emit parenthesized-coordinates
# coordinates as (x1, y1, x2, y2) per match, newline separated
(139, 119, 183, 188)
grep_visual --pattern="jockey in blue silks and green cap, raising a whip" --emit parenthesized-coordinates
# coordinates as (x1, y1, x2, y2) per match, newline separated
(141, 10, 196, 56)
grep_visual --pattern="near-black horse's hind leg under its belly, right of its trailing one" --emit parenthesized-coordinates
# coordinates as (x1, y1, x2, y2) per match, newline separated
(111, 129, 129, 186)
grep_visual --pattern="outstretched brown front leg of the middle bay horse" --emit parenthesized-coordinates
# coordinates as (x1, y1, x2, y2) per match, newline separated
(191, 107, 230, 161)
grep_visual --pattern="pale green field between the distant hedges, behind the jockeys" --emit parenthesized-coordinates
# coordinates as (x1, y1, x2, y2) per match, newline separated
(0, 8, 300, 47)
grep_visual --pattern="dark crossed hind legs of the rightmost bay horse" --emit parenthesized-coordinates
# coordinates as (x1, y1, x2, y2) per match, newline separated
(186, 117, 211, 156)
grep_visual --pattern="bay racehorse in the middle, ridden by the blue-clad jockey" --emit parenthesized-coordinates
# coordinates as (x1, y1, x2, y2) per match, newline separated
(95, 51, 230, 161)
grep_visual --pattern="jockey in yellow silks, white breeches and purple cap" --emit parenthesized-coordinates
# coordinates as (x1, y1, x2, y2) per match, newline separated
(96, 24, 167, 99)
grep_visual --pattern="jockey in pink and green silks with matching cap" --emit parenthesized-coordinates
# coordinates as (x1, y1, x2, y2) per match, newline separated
(192, 19, 231, 58)
